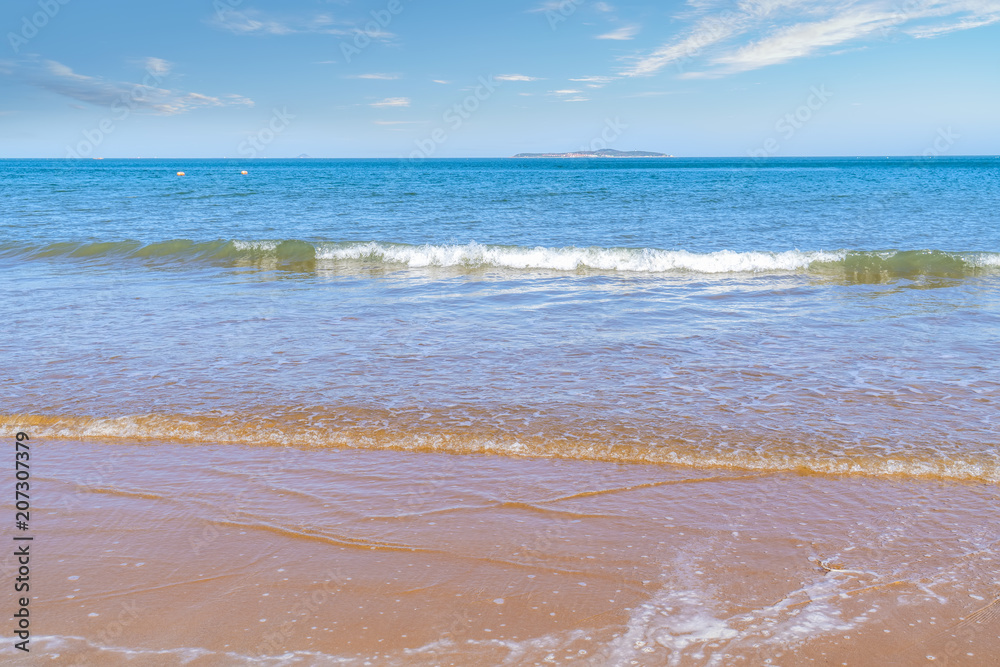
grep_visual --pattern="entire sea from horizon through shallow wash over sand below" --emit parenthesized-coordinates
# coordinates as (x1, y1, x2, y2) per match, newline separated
(0, 157, 1000, 667)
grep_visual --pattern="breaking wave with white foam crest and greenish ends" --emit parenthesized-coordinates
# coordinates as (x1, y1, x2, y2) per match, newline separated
(0, 239, 1000, 281)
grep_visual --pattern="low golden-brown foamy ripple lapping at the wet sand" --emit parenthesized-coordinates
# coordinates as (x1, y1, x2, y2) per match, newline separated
(0, 406, 1000, 485)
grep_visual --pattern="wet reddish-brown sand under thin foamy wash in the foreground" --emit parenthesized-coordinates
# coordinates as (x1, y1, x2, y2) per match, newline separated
(0, 440, 1000, 665)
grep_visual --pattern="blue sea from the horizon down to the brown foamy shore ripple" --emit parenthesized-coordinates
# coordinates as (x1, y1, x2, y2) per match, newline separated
(0, 157, 1000, 483)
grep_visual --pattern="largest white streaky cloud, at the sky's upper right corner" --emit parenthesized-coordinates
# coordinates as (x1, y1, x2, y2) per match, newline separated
(624, 0, 1000, 77)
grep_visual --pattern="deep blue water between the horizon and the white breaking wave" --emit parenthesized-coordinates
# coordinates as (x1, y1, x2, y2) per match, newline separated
(0, 157, 1000, 252)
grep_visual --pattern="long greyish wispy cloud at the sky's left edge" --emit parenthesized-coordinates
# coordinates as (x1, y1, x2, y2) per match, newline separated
(0, 58, 253, 115)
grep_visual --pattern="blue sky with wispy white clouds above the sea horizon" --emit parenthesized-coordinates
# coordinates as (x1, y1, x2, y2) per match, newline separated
(0, 0, 1000, 158)
